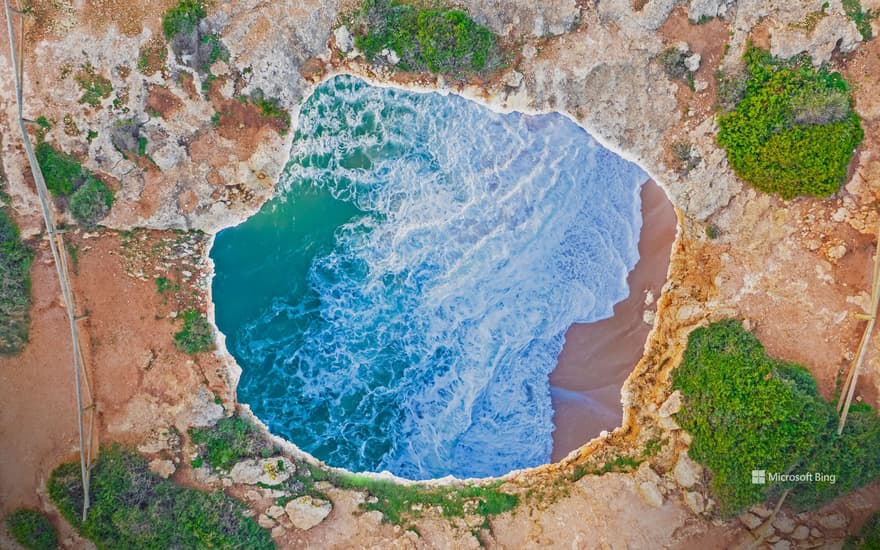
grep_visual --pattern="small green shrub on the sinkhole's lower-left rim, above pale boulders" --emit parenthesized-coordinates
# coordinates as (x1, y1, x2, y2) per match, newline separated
(189, 416, 266, 471)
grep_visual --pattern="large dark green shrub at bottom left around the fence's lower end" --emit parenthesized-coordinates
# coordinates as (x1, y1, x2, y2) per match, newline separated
(48, 446, 275, 550)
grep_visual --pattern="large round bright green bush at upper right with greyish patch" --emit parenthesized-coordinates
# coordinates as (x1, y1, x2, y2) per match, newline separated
(718, 46, 864, 199)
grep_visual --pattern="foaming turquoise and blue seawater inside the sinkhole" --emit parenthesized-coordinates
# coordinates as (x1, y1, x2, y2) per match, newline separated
(211, 77, 647, 479)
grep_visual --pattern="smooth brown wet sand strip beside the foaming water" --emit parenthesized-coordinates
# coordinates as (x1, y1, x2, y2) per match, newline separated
(550, 180, 676, 462)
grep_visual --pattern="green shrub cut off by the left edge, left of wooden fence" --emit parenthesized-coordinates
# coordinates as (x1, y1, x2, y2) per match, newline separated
(0, 208, 34, 355)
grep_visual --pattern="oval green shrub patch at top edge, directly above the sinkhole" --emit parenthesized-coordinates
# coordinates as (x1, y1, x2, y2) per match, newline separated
(352, 0, 503, 76)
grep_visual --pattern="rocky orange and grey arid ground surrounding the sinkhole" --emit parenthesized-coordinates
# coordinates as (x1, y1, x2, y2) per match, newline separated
(0, 0, 880, 549)
